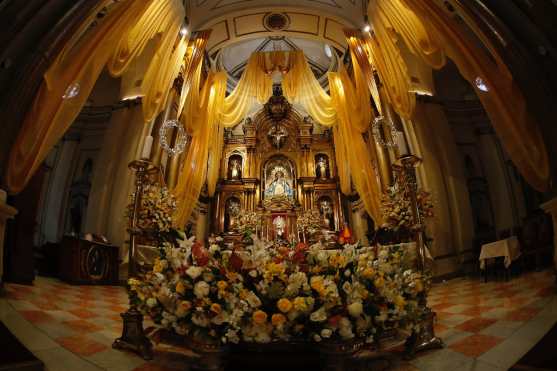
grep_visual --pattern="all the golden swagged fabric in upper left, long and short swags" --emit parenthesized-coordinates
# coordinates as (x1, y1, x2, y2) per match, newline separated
(6, 0, 187, 193)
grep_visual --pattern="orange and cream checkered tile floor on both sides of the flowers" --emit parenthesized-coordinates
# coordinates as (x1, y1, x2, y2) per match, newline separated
(0, 271, 557, 371)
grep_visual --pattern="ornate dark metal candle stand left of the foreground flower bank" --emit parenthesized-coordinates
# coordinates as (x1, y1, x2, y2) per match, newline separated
(112, 159, 158, 360)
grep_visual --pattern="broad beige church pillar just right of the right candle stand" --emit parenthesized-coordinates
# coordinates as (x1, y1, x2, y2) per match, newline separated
(405, 102, 473, 276)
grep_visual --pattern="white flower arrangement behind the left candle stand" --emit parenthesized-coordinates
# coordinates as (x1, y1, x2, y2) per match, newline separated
(125, 184, 177, 246)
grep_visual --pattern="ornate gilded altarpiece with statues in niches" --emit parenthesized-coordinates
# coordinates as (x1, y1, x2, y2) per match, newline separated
(211, 89, 345, 241)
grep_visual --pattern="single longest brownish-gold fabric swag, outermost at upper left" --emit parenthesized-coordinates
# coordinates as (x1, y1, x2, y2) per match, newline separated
(6, 0, 149, 193)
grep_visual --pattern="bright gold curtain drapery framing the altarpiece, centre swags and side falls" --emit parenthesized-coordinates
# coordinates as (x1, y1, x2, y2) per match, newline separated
(174, 51, 381, 225)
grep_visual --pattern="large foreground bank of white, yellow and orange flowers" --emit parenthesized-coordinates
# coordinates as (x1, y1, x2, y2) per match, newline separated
(129, 237, 427, 344)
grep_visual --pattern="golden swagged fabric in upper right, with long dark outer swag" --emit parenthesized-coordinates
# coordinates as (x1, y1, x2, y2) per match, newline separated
(366, 0, 550, 191)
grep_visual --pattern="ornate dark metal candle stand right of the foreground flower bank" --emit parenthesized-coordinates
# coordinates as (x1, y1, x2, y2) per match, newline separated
(394, 155, 444, 356)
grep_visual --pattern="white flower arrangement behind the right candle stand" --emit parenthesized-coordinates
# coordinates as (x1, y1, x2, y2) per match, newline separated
(381, 187, 434, 231)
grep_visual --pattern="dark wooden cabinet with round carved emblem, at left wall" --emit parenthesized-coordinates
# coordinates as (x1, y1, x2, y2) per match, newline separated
(59, 236, 119, 285)
